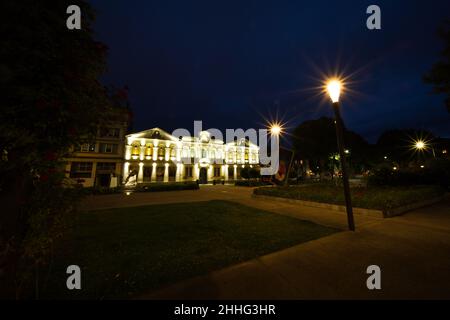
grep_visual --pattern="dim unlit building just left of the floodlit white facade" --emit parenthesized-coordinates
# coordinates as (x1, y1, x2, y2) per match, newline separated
(66, 109, 130, 187)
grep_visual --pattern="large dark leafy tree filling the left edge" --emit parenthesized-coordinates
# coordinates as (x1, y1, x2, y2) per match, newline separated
(0, 0, 118, 296)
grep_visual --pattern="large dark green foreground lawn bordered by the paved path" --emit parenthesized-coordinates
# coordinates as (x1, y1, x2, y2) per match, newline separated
(41, 201, 339, 299)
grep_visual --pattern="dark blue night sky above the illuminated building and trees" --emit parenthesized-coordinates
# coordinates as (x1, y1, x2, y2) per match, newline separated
(91, 0, 450, 142)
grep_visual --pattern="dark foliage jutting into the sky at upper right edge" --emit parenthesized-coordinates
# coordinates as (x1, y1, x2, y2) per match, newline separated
(424, 20, 450, 112)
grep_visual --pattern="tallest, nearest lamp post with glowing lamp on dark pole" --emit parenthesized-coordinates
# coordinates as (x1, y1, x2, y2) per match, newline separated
(326, 79, 355, 231)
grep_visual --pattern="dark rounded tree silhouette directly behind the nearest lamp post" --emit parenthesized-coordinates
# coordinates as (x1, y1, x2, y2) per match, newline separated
(293, 117, 369, 173)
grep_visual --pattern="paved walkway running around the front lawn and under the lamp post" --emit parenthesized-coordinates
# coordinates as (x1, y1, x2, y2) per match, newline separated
(84, 186, 450, 299)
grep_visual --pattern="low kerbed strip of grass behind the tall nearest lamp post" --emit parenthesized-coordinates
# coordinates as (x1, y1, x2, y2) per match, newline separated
(254, 183, 445, 210)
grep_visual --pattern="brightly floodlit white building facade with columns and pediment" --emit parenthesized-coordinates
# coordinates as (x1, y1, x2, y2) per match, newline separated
(123, 128, 259, 185)
